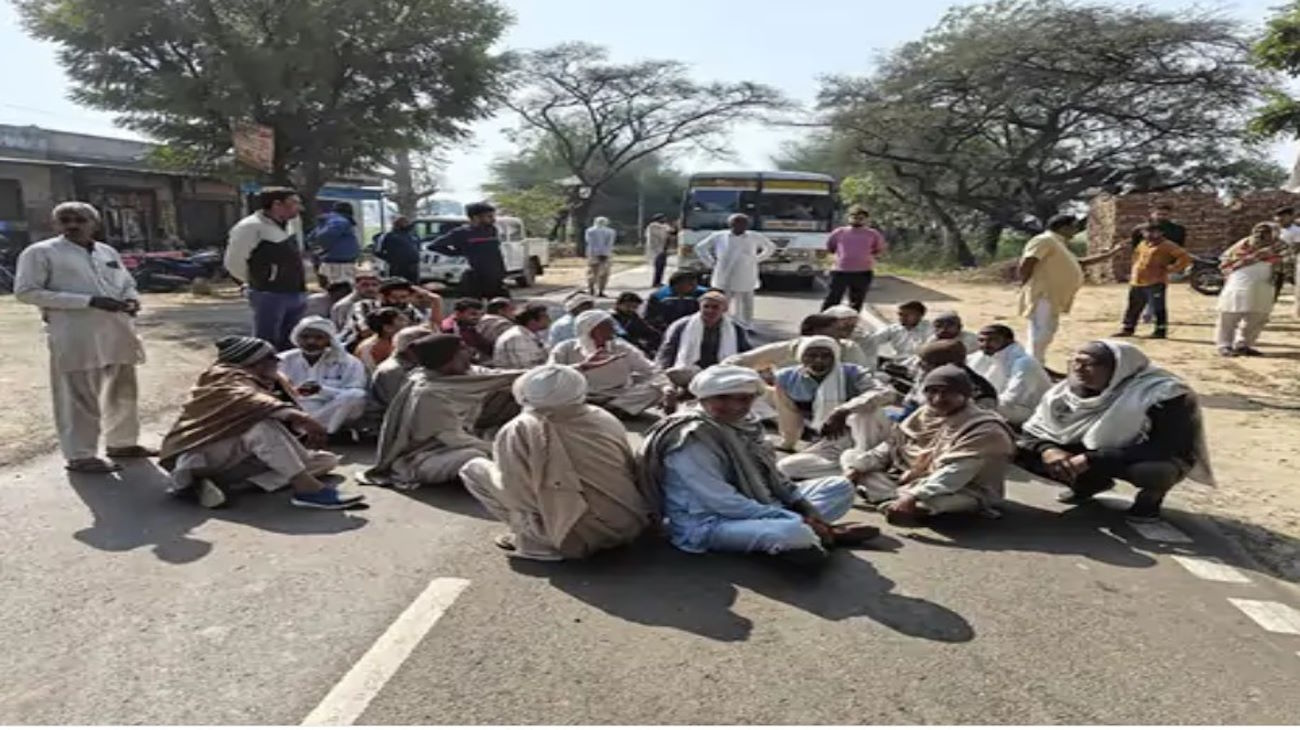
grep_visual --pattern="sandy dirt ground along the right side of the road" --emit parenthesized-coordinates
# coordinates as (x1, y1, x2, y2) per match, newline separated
(881, 275, 1300, 581)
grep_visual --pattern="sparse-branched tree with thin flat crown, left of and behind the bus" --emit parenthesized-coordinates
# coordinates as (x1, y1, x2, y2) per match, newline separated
(506, 43, 790, 252)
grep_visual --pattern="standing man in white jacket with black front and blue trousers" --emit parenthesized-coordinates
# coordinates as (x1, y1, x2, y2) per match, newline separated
(225, 187, 307, 349)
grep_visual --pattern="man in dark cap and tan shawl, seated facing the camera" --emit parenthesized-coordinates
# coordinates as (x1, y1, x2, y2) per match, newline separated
(844, 365, 1015, 523)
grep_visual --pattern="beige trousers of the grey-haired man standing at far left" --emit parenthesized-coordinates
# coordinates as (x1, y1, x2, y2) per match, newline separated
(49, 359, 140, 461)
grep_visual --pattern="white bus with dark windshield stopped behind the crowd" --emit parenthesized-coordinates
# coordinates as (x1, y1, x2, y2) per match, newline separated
(677, 171, 839, 287)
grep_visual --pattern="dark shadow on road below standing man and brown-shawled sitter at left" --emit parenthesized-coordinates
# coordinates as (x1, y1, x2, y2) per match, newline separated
(68, 460, 367, 564)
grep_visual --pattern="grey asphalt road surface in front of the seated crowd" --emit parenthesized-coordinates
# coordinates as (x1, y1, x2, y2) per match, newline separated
(0, 271, 1300, 725)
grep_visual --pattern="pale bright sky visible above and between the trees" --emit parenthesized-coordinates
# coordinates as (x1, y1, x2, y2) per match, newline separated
(0, 0, 1295, 201)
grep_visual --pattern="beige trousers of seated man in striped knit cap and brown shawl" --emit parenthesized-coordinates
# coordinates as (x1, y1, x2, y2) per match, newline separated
(172, 418, 339, 492)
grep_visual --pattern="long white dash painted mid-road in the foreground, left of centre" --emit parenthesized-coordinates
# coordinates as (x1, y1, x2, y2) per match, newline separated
(302, 578, 469, 725)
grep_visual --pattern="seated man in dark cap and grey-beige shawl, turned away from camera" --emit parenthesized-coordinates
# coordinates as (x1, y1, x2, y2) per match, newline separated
(364, 334, 519, 488)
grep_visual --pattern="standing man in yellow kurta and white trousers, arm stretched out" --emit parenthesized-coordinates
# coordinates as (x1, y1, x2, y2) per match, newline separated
(1018, 216, 1122, 362)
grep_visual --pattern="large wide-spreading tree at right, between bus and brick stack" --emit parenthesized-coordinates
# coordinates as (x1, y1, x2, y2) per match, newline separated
(820, 0, 1265, 265)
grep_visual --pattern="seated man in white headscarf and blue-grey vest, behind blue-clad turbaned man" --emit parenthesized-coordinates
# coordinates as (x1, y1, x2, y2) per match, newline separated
(775, 336, 898, 479)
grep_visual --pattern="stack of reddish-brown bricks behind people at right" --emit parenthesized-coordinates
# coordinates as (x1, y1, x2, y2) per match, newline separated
(1088, 190, 1300, 282)
